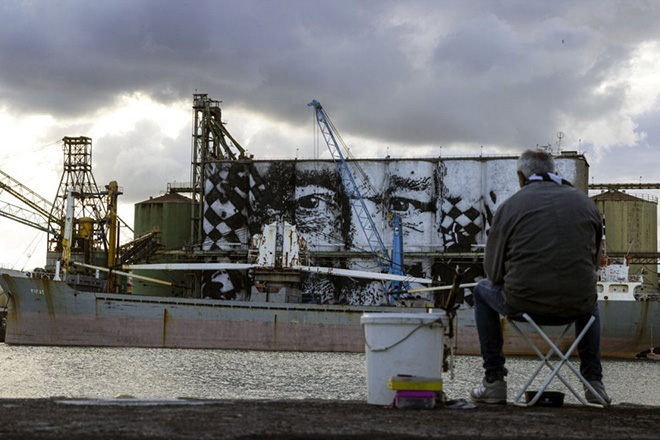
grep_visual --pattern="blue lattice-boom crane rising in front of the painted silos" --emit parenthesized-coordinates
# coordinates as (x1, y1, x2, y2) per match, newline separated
(307, 99, 408, 294)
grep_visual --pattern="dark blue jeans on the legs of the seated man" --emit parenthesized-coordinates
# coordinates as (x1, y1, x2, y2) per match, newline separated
(474, 279, 603, 380)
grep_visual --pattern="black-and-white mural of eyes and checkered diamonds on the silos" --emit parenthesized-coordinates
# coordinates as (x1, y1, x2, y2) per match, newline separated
(203, 157, 588, 305)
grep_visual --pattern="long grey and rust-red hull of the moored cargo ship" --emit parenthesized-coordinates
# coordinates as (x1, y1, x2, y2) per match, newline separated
(0, 275, 660, 358)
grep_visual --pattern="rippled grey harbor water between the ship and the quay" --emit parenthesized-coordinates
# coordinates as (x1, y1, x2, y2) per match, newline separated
(0, 343, 660, 406)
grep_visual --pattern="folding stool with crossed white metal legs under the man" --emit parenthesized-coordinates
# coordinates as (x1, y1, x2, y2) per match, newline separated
(507, 313, 607, 408)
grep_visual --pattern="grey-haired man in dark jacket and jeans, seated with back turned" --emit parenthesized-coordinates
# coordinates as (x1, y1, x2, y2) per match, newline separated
(470, 150, 611, 404)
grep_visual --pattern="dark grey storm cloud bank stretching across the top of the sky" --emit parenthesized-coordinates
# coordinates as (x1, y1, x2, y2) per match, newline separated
(0, 0, 660, 150)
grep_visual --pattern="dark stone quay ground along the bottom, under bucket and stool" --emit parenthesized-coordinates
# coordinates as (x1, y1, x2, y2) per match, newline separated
(0, 398, 660, 440)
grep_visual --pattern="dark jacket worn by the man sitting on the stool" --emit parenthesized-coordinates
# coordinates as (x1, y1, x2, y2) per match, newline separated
(484, 181, 603, 316)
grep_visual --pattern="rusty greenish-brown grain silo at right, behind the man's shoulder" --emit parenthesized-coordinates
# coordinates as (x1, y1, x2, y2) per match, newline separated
(592, 190, 658, 292)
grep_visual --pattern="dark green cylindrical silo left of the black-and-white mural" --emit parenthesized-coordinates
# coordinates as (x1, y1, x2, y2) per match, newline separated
(133, 194, 193, 296)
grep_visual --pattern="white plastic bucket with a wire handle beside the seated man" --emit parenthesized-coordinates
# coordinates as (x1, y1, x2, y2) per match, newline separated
(360, 312, 448, 405)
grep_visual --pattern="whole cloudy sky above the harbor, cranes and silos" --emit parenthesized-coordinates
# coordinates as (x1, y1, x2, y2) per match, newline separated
(0, 0, 660, 269)
